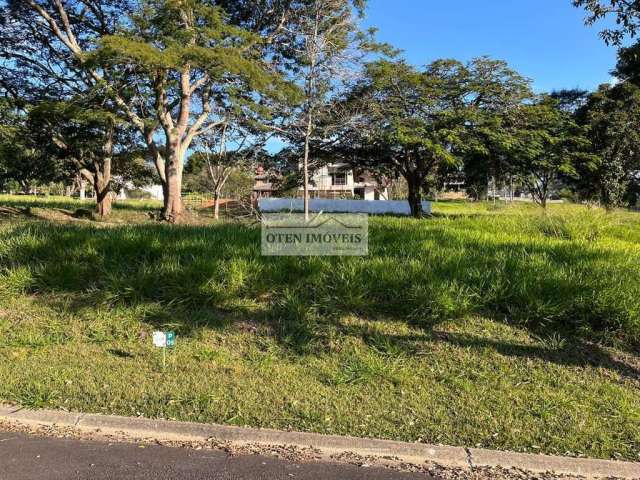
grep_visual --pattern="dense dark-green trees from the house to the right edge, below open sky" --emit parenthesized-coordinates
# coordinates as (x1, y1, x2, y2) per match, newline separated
(318, 52, 640, 216)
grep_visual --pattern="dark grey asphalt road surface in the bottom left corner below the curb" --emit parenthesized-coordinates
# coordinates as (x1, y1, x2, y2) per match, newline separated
(0, 432, 428, 480)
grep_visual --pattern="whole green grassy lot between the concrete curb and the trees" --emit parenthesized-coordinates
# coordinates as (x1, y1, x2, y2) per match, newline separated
(0, 197, 640, 460)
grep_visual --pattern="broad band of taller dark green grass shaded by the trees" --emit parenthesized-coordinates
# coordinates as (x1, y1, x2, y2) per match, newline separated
(0, 219, 640, 369)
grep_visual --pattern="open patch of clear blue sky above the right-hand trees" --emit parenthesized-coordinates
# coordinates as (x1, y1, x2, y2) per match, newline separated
(365, 0, 616, 92)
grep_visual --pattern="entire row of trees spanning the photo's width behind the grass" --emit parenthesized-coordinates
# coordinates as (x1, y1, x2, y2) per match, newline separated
(0, 0, 640, 222)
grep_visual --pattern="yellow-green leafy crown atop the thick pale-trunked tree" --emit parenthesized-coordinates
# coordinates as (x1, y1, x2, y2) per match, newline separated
(92, 0, 297, 106)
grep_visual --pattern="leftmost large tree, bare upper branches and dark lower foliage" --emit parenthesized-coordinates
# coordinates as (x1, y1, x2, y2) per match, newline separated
(0, 0, 135, 210)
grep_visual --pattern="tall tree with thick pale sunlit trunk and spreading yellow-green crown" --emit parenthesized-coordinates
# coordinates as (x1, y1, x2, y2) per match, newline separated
(98, 0, 298, 221)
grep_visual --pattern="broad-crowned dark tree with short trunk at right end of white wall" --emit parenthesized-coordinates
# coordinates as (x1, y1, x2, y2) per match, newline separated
(338, 58, 529, 217)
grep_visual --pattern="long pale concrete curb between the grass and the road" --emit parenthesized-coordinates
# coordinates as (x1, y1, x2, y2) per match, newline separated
(0, 405, 640, 479)
